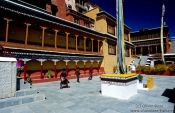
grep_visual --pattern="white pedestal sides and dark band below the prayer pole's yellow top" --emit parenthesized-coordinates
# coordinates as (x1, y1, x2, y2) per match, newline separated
(101, 78, 137, 100)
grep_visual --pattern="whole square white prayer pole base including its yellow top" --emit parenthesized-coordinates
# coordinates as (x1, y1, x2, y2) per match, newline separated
(101, 74, 137, 100)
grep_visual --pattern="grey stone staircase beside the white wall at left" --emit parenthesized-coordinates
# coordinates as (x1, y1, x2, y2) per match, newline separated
(0, 78, 46, 109)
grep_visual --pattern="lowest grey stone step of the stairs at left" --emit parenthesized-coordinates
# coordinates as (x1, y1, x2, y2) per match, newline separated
(0, 94, 46, 109)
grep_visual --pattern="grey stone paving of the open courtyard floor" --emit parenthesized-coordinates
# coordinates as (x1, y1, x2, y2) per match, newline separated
(0, 76, 175, 113)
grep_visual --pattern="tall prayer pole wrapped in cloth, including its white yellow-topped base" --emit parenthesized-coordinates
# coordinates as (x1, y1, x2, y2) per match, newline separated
(101, 0, 137, 99)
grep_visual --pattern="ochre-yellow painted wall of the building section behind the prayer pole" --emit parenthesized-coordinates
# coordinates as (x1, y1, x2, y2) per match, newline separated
(85, 7, 132, 73)
